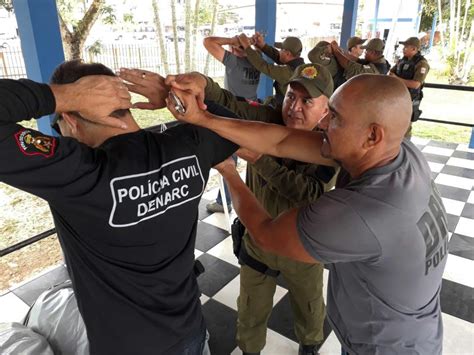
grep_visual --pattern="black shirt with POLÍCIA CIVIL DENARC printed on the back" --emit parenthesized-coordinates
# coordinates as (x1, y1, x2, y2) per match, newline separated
(0, 80, 237, 354)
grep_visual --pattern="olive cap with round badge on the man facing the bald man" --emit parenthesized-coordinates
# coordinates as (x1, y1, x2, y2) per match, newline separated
(288, 64, 334, 98)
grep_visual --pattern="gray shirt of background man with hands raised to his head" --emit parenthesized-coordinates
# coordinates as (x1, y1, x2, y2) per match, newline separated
(222, 51, 260, 100)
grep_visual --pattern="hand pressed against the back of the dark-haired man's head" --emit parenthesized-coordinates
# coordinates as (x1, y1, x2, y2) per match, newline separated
(51, 75, 132, 128)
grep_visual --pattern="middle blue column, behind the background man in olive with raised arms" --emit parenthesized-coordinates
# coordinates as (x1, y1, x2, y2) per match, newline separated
(255, 0, 276, 99)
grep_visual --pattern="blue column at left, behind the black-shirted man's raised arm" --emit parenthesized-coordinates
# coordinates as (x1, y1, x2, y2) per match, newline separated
(13, 0, 64, 134)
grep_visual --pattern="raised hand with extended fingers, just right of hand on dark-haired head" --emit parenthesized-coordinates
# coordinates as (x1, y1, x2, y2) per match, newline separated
(119, 68, 170, 110)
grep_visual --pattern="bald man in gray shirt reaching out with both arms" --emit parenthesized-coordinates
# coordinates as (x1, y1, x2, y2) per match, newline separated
(168, 73, 448, 355)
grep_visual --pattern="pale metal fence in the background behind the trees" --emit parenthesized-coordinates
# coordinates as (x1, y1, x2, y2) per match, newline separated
(0, 42, 224, 79)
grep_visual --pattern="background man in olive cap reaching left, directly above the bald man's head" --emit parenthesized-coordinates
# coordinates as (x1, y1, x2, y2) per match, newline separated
(331, 38, 390, 80)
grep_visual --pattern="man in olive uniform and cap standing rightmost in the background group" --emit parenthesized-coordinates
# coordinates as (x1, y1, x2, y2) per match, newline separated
(390, 37, 430, 125)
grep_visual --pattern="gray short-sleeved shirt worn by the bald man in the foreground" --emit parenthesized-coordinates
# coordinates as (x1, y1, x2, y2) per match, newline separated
(298, 141, 448, 355)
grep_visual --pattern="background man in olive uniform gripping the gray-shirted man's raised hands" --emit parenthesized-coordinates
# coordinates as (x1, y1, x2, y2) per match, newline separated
(239, 33, 304, 106)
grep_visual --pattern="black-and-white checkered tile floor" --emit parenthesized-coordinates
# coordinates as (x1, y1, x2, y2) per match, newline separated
(0, 138, 474, 355)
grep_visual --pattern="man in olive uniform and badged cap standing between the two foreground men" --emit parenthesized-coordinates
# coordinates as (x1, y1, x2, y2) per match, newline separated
(167, 64, 336, 355)
